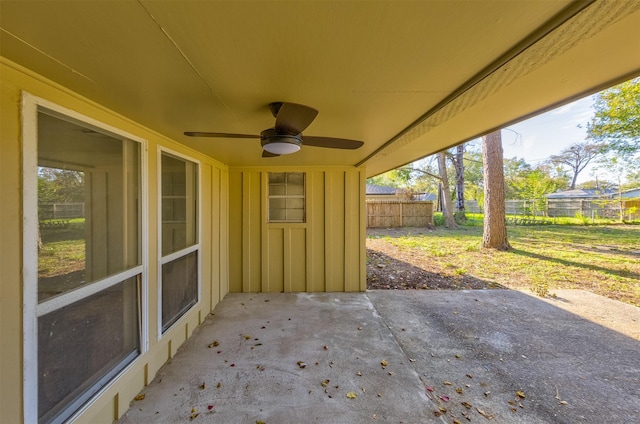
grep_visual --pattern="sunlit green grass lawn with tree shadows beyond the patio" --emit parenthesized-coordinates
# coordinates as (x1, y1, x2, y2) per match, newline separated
(368, 225, 640, 306)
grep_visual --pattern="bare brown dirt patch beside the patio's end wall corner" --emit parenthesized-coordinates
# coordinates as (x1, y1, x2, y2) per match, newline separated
(366, 228, 505, 290)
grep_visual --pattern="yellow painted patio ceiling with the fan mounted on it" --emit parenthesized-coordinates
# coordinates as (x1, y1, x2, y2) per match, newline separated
(0, 0, 640, 176)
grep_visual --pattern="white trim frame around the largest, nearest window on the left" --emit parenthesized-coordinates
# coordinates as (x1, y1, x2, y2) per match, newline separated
(21, 91, 149, 423)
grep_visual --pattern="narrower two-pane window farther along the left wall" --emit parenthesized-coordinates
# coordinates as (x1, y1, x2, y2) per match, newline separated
(160, 152, 200, 333)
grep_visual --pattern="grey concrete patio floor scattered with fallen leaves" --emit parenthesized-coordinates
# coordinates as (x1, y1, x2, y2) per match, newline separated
(120, 290, 640, 424)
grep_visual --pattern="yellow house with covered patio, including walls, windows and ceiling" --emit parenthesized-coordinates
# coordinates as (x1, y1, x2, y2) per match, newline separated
(0, 0, 640, 424)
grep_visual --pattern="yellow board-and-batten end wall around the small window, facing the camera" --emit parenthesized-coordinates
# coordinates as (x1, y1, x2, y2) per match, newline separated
(229, 168, 366, 293)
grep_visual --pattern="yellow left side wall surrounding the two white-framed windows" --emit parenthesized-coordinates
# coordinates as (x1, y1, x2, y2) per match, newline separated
(0, 57, 229, 423)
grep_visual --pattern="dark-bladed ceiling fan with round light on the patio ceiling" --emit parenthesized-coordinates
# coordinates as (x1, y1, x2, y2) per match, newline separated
(184, 102, 364, 158)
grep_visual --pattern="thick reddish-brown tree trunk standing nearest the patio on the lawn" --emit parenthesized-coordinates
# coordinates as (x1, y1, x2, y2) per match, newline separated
(482, 130, 511, 250)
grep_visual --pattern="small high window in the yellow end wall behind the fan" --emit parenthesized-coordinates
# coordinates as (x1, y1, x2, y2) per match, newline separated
(269, 172, 305, 222)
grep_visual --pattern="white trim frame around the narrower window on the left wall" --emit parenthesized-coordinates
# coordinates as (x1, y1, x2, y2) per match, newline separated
(156, 146, 202, 341)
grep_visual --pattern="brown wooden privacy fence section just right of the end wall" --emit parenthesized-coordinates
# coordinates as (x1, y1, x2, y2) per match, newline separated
(367, 200, 433, 228)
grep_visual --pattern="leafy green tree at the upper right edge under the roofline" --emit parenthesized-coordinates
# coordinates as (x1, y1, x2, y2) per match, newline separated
(587, 77, 640, 155)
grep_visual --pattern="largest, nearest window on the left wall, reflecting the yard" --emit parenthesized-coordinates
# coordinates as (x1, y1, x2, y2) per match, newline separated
(30, 106, 144, 423)
